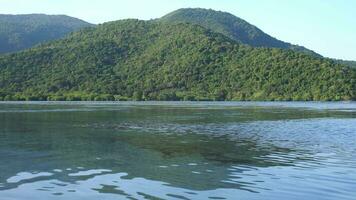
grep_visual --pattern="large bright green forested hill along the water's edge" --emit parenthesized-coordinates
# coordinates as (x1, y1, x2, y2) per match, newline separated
(0, 20, 356, 100)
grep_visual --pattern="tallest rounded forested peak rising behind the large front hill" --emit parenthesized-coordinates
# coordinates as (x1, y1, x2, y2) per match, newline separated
(158, 8, 320, 56)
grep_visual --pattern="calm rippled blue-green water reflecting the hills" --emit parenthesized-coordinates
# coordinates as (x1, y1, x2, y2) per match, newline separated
(0, 102, 356, 200)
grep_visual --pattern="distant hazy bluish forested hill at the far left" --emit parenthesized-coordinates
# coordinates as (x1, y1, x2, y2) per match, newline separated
(0, 14, 92, 53)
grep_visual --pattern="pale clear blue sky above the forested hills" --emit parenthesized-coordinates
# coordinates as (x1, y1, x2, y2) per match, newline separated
(0, 0, 356, 60)
